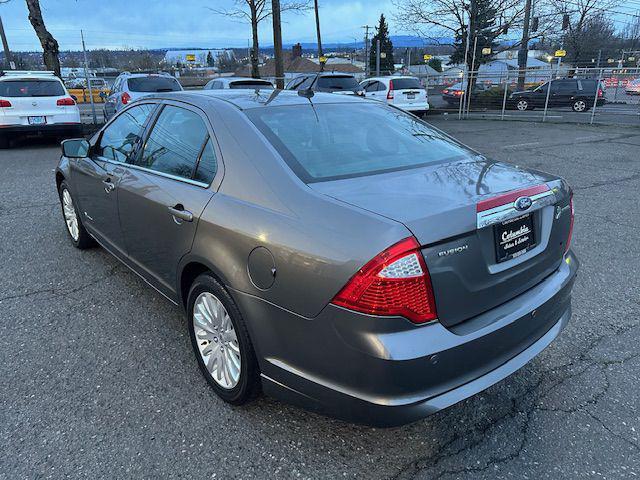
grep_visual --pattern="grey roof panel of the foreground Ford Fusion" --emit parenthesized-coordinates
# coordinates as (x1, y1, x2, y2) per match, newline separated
(145, 89, 368, 110)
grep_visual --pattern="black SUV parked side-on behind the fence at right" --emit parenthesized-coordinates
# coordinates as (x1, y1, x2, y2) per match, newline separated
(508, 78, 605, 112)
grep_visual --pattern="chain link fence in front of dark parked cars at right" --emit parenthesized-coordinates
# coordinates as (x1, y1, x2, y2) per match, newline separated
(410, 66, 640, 125)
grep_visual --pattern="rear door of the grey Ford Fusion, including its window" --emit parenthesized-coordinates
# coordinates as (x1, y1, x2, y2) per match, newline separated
(118, 102, 219, 299)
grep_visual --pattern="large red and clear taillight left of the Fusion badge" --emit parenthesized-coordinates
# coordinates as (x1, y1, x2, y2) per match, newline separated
(332, 237, 437, 323)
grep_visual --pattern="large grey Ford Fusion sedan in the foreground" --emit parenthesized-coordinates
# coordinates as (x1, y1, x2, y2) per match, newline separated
(55, 91, 578, 426)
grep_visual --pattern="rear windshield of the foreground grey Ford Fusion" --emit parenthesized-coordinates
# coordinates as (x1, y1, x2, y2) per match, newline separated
(247, 103, 474, 183)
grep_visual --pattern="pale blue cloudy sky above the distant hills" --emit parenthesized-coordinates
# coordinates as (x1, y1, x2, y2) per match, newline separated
(0, 0, 402, 51)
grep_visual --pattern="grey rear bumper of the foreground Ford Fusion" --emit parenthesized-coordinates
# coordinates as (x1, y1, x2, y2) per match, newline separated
(234, 253, 578, 426)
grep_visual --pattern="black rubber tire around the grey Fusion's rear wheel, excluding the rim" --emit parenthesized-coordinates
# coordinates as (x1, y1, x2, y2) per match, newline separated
(187, 273, 261, 405)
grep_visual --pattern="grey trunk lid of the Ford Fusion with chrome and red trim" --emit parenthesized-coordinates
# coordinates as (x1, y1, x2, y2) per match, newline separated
(310, 157, 569, 326)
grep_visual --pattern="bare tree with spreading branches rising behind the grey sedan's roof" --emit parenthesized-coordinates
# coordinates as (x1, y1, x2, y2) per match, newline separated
(210, 0, 310, 78)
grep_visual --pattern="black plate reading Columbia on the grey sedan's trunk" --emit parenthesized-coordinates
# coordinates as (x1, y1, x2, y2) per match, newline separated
(493, 213, 537, 263)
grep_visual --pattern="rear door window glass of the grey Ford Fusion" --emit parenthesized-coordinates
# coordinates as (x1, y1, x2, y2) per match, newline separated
(137, 105, 208, 179)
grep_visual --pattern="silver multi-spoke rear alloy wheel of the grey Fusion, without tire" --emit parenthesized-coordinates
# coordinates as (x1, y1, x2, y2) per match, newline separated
(192, 292, 242, 389)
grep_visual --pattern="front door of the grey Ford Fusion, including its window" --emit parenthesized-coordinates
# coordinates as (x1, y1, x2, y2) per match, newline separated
(71, 103, 155, 256)
